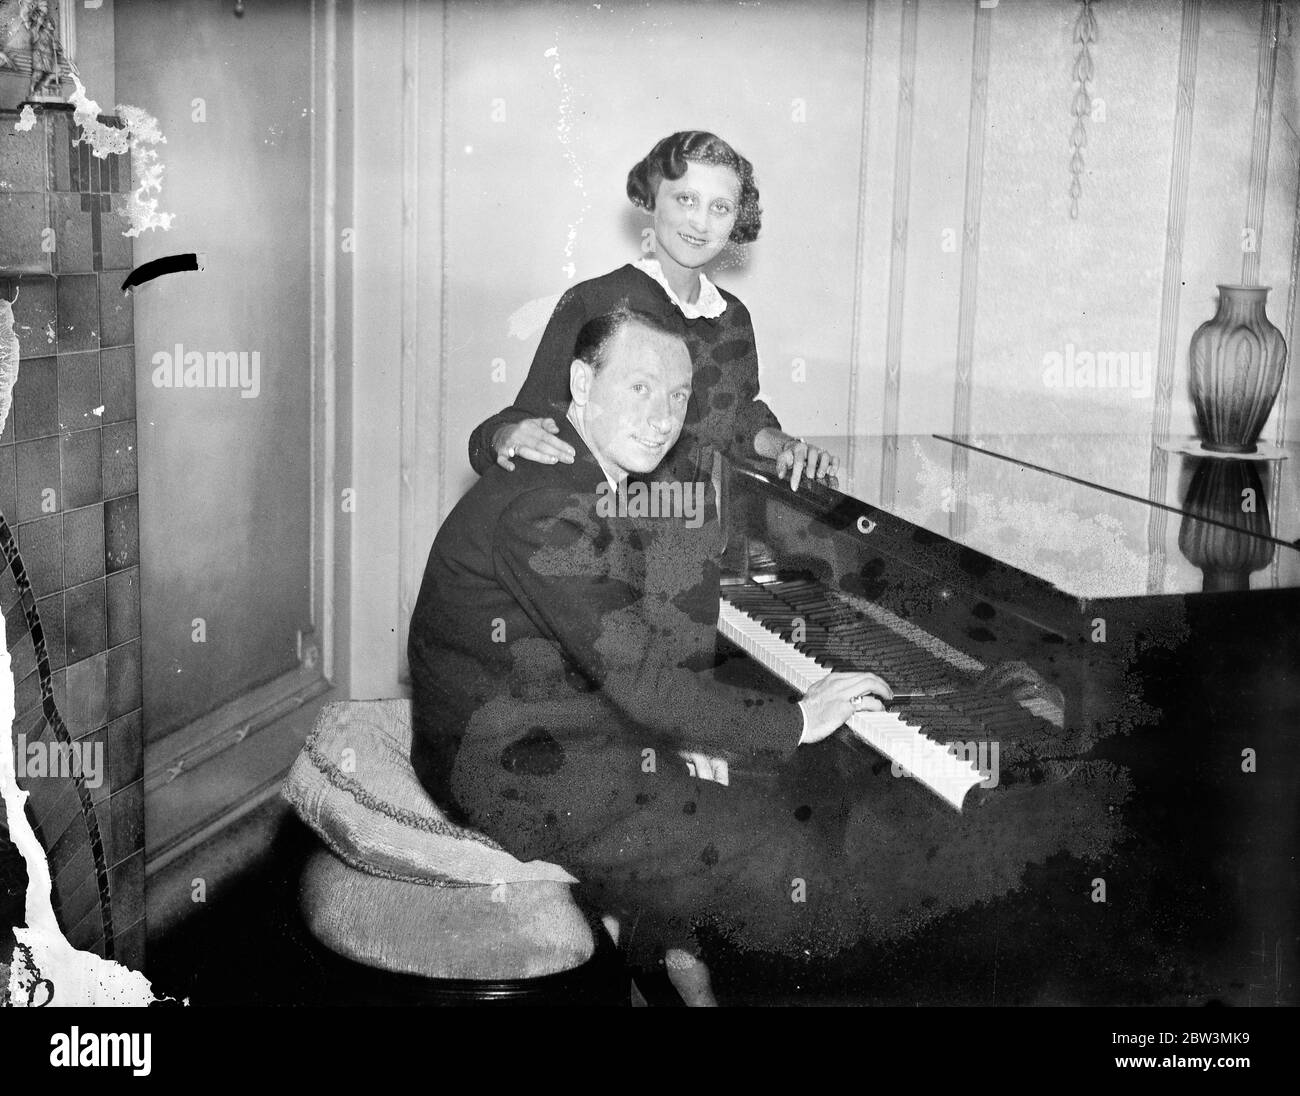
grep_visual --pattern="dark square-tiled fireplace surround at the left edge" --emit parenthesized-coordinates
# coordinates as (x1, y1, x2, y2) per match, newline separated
(0, 100, 144, 969)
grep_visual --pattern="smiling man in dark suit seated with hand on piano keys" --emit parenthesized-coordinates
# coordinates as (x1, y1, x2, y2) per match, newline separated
(410, 301, 891, 1000)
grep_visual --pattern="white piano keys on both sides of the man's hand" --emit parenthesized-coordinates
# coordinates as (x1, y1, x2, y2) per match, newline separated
(718, 589, 988, 810)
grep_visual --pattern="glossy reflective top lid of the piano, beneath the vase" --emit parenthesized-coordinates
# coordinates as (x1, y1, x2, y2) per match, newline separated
(764, 434, 1300, 599)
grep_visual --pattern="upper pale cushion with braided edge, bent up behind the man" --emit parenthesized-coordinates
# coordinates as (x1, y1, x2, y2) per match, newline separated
(283, 699, 577, 889)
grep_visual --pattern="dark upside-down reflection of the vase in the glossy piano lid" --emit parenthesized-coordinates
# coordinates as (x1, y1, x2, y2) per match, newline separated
(1178, 456, 1274, 592)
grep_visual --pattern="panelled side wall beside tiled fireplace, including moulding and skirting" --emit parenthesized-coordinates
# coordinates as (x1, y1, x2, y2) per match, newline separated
(109, 0, 348, 933)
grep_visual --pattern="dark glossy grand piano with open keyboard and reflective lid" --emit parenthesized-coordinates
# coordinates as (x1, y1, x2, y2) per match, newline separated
(719, 436, 1300, 1005)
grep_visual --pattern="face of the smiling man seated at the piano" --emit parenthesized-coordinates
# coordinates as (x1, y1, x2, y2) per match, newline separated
(584, 324, 692, 475)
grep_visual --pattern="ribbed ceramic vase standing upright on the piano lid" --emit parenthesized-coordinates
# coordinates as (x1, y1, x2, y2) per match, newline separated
(1190, 285, 1287, 452)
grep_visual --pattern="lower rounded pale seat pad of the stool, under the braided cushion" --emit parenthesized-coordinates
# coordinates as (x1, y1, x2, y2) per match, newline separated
(299, 849, 595, 980)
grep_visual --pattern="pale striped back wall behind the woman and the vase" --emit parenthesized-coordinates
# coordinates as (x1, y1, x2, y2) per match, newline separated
(346, 0, 1300, 696)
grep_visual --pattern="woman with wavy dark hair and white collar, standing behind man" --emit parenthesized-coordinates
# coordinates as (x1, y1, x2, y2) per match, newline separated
(469, 130, 837, 490)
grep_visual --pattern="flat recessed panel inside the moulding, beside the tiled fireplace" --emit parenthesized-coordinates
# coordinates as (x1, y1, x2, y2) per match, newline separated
(116, 0, 312, 742)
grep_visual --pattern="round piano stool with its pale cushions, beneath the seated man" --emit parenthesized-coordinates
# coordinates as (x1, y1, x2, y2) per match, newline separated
(283, 699, 629, 1005)
